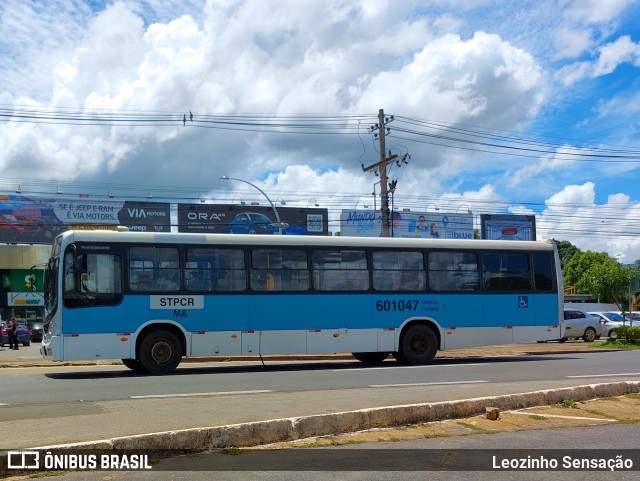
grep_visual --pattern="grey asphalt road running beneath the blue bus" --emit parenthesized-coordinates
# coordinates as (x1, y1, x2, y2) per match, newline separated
(0, 344, 640, 448)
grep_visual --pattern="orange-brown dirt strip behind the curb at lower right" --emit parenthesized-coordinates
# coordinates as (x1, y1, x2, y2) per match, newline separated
(258, 393, 640, 449)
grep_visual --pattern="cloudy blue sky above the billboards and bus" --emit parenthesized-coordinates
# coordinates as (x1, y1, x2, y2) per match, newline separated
(0, 0, 640, 263)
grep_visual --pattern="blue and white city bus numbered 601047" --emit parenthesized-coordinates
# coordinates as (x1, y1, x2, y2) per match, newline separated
(41, 230, 564, 374)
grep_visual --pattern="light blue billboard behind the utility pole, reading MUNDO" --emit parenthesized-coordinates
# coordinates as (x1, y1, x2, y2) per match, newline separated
(340, 210, 473, 239)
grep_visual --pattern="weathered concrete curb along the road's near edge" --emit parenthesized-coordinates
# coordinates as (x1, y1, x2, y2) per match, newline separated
(33, 381, 640, 453)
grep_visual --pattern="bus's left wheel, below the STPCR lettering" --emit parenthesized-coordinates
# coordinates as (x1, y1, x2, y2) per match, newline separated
(138, 330, 182, 375)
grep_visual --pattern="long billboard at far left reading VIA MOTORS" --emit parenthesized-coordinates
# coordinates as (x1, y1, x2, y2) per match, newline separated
(0, 195, 171, 244)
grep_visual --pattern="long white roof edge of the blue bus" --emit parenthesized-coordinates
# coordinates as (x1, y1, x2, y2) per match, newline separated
(55, 230, 553, 251)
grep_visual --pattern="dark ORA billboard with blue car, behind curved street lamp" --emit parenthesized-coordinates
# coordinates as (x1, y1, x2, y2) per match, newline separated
(178, 204, 329, 235)
